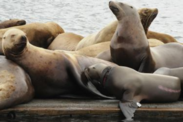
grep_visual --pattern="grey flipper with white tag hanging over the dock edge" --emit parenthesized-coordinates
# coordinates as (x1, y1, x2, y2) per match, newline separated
(119, 101, 141, 120)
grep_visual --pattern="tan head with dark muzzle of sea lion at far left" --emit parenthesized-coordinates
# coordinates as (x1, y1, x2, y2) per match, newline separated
(2, 28, 27, 55)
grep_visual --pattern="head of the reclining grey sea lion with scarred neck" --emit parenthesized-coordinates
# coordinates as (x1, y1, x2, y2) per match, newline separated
(84, 63, 107, 82)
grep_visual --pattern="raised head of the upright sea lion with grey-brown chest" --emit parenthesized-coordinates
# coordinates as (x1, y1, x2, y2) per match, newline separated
(109, 1, 138, 20)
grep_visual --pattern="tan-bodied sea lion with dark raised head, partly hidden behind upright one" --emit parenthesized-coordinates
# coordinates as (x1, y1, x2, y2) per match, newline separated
(76, 8, 158, 50)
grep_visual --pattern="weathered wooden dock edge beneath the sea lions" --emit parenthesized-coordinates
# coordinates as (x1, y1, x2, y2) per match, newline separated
(0, 99, 183, 122)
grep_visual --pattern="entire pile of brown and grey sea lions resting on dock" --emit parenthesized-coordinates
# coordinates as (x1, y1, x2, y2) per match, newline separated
(0, 1, 183, 120)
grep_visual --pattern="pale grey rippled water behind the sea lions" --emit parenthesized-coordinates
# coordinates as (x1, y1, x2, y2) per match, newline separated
(0, 0, 183, 122)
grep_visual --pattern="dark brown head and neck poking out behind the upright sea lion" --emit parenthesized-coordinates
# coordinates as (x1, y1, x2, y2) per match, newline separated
(138, 8, 158, 34)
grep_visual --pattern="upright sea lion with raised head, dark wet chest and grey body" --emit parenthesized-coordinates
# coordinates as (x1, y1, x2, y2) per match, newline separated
(109, 2, 183, 72)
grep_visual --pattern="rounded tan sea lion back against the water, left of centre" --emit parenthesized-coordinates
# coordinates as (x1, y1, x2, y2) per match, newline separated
(48, 32, 83, 51)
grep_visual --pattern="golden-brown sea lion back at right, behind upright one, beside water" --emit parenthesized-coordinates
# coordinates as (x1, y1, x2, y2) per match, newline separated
(147, 31, 177, 43)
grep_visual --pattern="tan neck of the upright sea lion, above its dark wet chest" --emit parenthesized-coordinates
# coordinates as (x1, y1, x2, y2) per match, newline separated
(116, 16, 149, 47)
